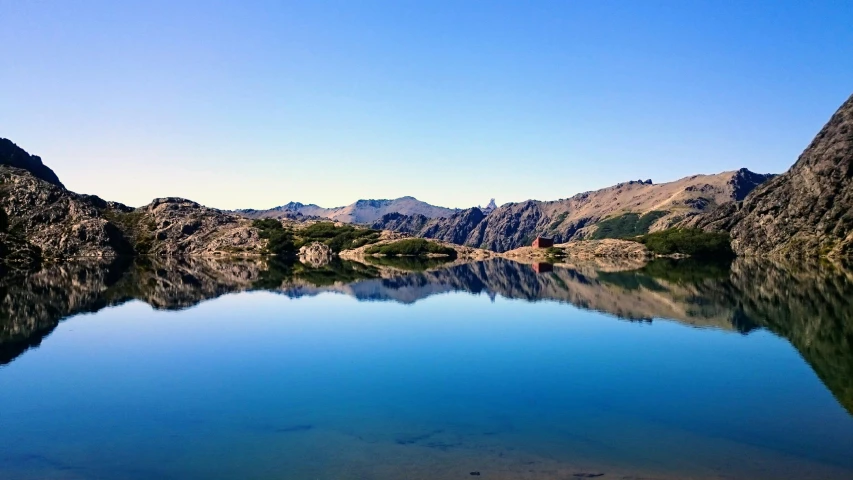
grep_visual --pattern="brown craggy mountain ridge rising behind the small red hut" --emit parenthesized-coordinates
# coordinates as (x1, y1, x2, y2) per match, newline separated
(371, 169, 773, 252)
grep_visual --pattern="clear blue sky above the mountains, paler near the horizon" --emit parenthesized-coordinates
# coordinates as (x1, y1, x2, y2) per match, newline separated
(0, 0, 853, 208)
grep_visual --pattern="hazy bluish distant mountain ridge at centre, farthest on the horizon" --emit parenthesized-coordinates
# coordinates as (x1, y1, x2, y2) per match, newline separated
(234, 196, 459, 223)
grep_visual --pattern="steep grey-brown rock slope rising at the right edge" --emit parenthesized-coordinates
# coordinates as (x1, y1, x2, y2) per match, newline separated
(686, 96, 853, 257)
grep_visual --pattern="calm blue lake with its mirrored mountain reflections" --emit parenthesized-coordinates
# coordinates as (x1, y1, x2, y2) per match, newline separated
(0, 259, 853, 480)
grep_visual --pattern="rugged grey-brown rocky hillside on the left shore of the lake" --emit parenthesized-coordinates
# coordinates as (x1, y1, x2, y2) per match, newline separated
(0, 142, 267, 264)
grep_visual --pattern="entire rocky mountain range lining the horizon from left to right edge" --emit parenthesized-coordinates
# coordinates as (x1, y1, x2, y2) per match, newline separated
(0, 92, 853, 262)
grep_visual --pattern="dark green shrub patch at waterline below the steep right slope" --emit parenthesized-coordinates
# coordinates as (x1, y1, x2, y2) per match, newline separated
(636, 228, 734, 257)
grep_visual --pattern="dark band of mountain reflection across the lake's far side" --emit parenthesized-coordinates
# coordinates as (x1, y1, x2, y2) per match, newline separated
(5, 258, 853, 413)
